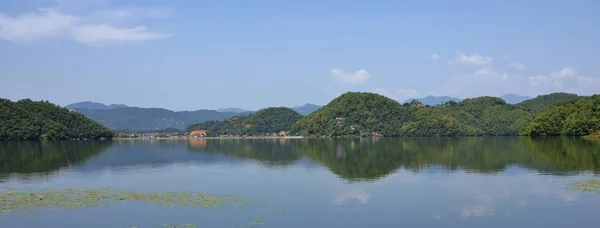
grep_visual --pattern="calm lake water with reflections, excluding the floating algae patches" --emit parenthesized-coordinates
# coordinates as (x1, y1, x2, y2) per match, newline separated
(0, 137, 600, 228)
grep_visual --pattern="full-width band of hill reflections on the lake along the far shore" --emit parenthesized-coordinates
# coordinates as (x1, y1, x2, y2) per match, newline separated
(0, 137, 600, 180)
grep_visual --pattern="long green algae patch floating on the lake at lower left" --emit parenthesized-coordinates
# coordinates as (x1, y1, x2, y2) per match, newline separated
(0, 189, 250, 214)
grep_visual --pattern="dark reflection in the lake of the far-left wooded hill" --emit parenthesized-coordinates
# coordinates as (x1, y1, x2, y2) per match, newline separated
(0, 141, 111, 180)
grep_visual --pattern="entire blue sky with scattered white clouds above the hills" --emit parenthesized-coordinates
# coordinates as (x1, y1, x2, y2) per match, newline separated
(0, 0, 600, 110)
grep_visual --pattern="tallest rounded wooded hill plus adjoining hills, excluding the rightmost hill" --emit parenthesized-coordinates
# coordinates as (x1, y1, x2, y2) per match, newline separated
(292, 93, 533, 136)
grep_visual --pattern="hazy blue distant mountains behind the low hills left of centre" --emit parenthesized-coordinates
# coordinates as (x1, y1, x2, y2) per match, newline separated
(65, 101, 321, 131)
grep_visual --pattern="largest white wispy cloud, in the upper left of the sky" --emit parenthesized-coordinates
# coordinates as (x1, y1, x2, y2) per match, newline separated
(0, 9, 169, 44)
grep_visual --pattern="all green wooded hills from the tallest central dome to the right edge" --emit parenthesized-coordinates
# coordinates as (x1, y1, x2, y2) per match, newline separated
(292, 92, 600, 137)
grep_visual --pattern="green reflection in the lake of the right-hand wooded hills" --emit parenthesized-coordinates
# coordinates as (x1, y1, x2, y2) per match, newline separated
(294, 137, 600, 180)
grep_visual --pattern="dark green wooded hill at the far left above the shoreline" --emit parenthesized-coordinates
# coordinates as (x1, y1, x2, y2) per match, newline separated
(0, 99, 113, 140)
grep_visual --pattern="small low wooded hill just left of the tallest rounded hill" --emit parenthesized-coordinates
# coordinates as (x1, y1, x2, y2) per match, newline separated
(187, 107, 302, 136)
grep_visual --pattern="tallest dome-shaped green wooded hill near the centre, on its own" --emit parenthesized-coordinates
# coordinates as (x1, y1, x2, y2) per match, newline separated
(292, 92, 410, 136)
